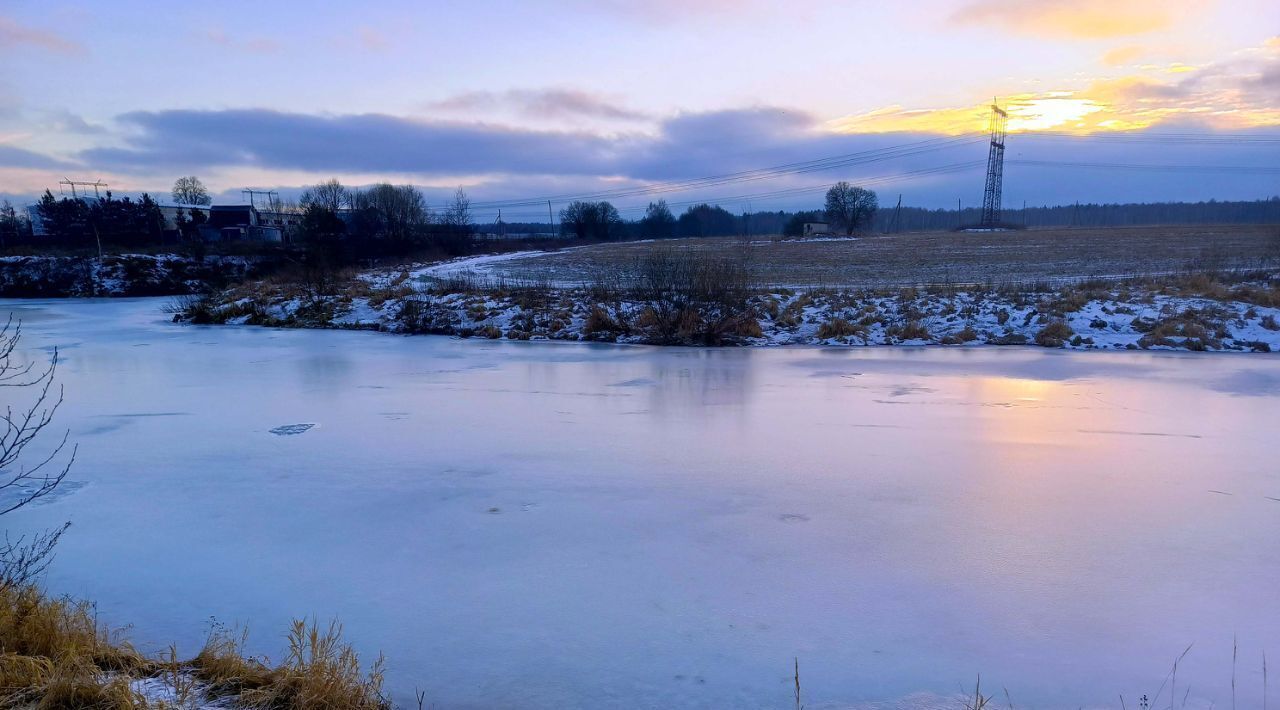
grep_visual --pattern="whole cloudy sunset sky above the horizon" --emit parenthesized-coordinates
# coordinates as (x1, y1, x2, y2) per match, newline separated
(0, 0, 1280, 221)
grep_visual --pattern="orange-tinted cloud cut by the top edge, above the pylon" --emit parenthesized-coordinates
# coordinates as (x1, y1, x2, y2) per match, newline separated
(951, 0, 1206, 38)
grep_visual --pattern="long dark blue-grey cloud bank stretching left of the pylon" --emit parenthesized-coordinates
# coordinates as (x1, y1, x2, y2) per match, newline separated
(78, 107, 875, 188)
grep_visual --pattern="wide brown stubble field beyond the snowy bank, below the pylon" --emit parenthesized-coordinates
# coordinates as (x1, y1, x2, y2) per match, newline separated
(473, 225, 1280, 289)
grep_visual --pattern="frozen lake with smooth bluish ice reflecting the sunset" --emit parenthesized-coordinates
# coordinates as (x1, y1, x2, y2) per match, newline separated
(0, 299, 1280, 710)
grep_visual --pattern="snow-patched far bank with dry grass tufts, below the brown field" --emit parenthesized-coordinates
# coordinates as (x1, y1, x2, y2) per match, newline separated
(175, 258, 1280, 352)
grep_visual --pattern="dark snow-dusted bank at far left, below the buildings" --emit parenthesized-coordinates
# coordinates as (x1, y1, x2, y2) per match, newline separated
(0, 253, 261, 298)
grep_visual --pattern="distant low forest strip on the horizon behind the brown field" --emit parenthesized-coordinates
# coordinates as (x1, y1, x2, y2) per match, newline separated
(491, 196, 1280, 238)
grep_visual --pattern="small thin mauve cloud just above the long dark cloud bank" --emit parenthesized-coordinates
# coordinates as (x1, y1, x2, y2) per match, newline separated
(426, 88, 650, 122)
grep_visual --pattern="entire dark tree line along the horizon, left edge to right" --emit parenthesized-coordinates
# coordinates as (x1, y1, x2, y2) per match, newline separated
(10, 175, 1280, 254)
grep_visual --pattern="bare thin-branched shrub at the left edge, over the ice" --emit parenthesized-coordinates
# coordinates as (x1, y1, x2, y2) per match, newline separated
(0, 316, 76, 588)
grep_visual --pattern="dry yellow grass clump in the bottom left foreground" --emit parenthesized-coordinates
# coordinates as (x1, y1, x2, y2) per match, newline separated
(0, 587, 390, 710)
